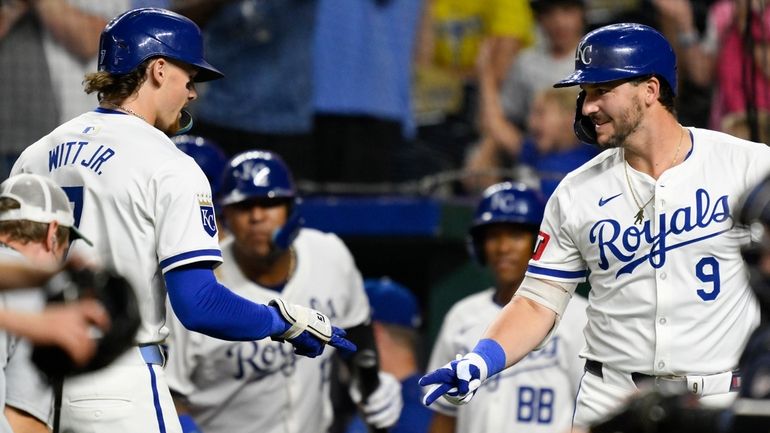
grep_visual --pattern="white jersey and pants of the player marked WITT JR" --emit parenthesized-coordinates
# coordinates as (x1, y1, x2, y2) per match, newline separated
(12, 109, 222, 433)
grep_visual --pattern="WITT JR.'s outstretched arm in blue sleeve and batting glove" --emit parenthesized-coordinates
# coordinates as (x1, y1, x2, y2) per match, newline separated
(164, 265, 355, 357)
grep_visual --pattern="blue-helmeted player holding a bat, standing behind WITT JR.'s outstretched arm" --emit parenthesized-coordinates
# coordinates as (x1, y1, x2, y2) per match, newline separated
(166, 151, 401, 433)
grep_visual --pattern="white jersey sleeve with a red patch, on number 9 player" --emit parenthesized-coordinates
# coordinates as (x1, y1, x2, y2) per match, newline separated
(526, 186, 587, 283)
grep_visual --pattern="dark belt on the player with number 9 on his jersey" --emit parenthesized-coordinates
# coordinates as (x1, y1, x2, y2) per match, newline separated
(585, 359, 741, 395)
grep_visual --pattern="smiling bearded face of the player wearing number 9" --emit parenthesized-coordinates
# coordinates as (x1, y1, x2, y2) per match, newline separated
(581, 80, 646, 148)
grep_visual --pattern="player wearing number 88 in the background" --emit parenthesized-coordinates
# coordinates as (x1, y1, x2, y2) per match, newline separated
(428, 182, 587, 433)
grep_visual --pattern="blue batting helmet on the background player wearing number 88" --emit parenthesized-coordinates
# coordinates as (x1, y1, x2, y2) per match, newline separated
(468, 182, 545, 265)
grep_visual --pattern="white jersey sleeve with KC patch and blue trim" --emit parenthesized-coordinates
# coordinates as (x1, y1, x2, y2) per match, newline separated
(150, 155, 222, 273)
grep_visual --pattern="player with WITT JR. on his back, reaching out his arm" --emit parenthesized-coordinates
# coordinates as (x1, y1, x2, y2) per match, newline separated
(12, 8, 354, 433)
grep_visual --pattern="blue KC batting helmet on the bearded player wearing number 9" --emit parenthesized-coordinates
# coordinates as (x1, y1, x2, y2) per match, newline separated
(554, 23, 676, 94)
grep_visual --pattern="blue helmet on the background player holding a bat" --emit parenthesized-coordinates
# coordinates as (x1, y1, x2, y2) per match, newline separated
(219, 150, 303, 250)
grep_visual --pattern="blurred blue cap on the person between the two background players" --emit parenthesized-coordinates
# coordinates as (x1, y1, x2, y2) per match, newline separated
(364, 277, 422, 328)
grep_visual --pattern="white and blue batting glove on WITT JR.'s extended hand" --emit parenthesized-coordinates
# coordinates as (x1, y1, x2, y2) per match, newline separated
(268, 298, 356, 358)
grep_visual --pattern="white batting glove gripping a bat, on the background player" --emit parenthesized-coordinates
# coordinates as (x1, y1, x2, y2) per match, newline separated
(349, 371, 404, 429)
